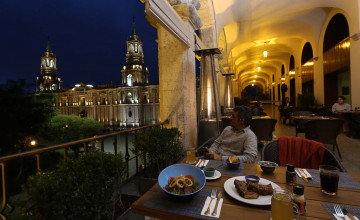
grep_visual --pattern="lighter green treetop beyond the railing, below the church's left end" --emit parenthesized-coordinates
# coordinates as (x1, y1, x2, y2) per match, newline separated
(44, 115, 102, 143)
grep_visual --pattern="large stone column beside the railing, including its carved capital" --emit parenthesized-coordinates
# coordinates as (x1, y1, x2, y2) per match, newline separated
(157, 3, 201, 148)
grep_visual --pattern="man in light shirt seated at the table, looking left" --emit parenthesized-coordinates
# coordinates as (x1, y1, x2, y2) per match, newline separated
(205, 106, 258, 163)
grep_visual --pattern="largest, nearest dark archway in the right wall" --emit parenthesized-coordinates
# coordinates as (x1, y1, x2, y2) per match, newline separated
(323, 14, 351, 105)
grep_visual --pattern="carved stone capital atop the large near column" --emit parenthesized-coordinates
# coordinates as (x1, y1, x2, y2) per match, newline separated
(168, 0, 204, 30)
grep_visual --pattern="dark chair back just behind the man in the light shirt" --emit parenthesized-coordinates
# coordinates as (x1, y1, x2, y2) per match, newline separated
(250, 118, 277, 142)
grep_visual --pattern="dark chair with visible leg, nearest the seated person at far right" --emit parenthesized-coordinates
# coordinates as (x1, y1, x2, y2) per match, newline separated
(305, 119, 344, 160)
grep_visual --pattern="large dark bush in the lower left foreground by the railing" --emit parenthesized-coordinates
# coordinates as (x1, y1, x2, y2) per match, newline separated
(15, 152, 126, 219)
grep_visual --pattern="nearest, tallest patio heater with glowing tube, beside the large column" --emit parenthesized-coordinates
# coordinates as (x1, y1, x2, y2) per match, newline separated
(195, 48, 221, 146)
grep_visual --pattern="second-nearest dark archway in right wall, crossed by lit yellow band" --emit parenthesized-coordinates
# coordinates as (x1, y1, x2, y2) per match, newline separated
(301, 42, 314, 95)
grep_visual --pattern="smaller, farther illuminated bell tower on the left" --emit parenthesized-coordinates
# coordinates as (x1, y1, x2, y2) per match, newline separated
(36, 38, 63, 92)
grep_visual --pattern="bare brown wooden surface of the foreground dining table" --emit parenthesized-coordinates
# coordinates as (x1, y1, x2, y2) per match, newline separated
(132, 161, 360, 220)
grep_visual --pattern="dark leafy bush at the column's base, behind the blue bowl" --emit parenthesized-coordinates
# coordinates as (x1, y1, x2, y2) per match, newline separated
(132, 127, 184, 175)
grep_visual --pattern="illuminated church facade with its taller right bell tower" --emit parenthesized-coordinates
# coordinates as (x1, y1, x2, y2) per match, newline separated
(37, 22, 160, 128)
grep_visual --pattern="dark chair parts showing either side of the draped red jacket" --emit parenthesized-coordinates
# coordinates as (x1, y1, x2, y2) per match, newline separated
(261, 140, 346, 172)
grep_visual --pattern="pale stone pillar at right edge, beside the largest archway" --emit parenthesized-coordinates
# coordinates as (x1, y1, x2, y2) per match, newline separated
(350, 33, 360, 110)
